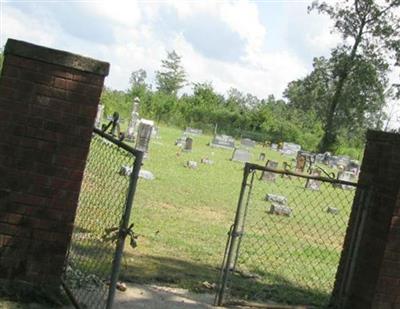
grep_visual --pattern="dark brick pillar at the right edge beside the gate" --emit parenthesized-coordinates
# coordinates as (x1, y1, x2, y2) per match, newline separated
(334, 131, 400, 309)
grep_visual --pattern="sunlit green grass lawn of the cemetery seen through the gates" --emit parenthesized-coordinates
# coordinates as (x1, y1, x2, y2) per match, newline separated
(70, 127, 354, 305)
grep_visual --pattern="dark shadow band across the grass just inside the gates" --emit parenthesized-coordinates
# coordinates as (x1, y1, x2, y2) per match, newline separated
(121, 255, 329, 308)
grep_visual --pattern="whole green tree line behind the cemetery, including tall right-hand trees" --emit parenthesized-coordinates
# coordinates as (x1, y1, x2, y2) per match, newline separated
(102, 0, 400, 157)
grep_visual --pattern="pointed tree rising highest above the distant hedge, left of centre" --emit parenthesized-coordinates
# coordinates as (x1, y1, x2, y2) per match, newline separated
(156, 50, 186, 96)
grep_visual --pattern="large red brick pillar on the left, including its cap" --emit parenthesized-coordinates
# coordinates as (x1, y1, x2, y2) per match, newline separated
(0, 39, 109, 290)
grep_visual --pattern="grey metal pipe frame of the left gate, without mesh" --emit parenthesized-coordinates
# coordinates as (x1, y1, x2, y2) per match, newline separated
(62, 128, 144, 309)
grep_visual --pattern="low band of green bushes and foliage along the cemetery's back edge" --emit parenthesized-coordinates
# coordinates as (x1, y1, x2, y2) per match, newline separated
(101, 77, 346, 151)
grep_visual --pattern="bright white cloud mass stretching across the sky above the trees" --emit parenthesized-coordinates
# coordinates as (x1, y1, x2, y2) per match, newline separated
(0, 0, 332, 97)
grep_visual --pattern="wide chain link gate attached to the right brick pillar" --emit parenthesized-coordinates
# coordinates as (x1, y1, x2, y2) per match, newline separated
(215, 163, 366, 308)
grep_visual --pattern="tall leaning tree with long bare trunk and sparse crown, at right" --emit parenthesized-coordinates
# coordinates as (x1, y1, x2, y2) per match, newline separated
(310, 0, 400, 150)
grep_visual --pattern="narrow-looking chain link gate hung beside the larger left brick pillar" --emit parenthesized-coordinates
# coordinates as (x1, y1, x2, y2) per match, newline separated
(63, 129, 143, 309)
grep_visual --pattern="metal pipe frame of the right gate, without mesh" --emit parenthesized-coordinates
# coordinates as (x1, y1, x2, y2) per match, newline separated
(214, 162, 373, 308)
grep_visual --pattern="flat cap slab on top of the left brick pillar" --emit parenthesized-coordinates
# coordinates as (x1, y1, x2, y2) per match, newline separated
(4, 39, 110, 76)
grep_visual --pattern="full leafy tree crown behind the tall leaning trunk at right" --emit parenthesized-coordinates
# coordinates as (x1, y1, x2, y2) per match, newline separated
(284, 49, 387, 150)
